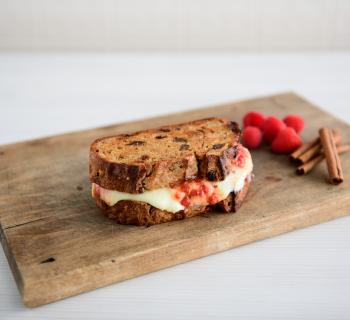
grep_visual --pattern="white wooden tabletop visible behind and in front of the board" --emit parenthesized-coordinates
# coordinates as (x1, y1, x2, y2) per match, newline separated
(0, 52, 350, 320)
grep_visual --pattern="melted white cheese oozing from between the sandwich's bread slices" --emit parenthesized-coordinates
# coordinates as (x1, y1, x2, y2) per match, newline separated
(92, 149, 253, 213)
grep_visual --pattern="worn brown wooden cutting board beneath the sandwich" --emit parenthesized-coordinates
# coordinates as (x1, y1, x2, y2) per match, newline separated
(0, 93, 350, 307)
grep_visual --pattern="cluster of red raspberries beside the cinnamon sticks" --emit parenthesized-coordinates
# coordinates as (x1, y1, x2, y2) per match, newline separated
(243, 111, 304, 153)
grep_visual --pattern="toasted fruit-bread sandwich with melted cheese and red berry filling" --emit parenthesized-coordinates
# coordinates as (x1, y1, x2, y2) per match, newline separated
(89, 118, 253, 226)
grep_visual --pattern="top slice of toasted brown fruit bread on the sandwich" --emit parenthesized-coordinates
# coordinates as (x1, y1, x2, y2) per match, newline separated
(89, 118, 240, 194)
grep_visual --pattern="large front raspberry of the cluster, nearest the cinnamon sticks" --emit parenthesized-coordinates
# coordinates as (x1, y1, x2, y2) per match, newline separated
(271, 127, 301, 153)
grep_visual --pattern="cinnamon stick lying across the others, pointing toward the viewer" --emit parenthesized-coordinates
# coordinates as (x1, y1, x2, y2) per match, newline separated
(319, 128, 344, 184)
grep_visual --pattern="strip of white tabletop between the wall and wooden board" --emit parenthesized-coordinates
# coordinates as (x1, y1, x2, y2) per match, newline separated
(0, 52, 350, 143)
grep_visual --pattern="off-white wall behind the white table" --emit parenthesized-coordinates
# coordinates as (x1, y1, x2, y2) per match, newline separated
(0, 0, 350, 50)
